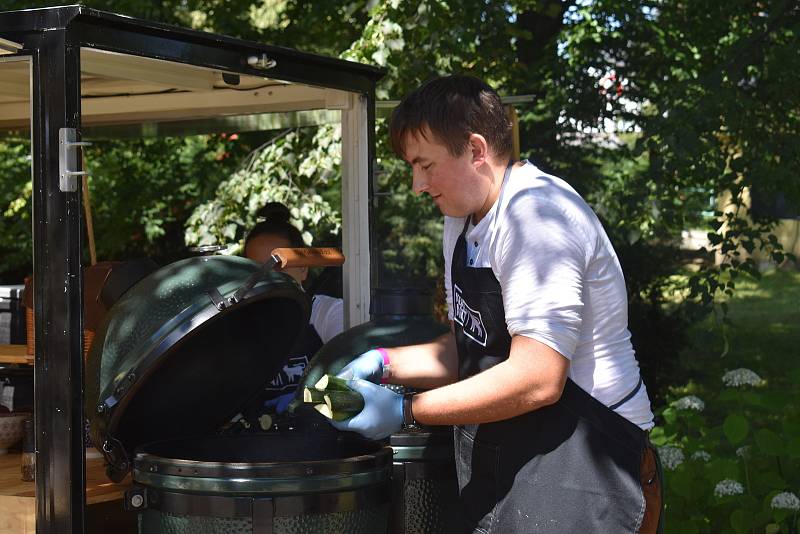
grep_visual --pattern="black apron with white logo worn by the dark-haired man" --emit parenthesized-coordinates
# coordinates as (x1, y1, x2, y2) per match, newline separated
(451, 164, 646, 534)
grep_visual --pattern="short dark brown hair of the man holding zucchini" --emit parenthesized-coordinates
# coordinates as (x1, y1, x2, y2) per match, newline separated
(389, 75, 512, 158)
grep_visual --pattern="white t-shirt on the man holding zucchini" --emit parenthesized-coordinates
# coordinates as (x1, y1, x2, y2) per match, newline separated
(443, 163, 653, 429)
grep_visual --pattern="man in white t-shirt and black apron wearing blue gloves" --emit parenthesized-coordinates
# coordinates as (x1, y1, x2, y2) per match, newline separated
(334, 76, 661, 534)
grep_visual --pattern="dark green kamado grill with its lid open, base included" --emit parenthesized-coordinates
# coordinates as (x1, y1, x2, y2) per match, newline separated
(86, 256, 392, 534)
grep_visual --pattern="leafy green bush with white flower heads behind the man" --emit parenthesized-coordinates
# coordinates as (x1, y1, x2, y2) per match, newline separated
(651, 368, 800, 534)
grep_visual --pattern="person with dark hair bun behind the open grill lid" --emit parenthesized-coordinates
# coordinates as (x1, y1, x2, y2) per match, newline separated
(244, 202, 344, 413)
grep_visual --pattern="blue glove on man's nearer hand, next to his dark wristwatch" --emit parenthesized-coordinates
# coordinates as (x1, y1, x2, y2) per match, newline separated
(330, 380, 403, 439)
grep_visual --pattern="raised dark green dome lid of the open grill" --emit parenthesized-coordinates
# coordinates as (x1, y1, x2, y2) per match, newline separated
(86, 256, 309, 480)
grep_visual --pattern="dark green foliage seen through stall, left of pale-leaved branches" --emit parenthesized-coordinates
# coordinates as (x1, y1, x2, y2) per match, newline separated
(85, 135, 246, 263)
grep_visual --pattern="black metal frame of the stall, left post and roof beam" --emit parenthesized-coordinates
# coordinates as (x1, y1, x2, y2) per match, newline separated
(0, 6, 383, 534)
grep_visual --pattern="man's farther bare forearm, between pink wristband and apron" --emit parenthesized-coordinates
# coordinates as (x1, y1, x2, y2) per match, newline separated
(385, 324, 458, 389)
